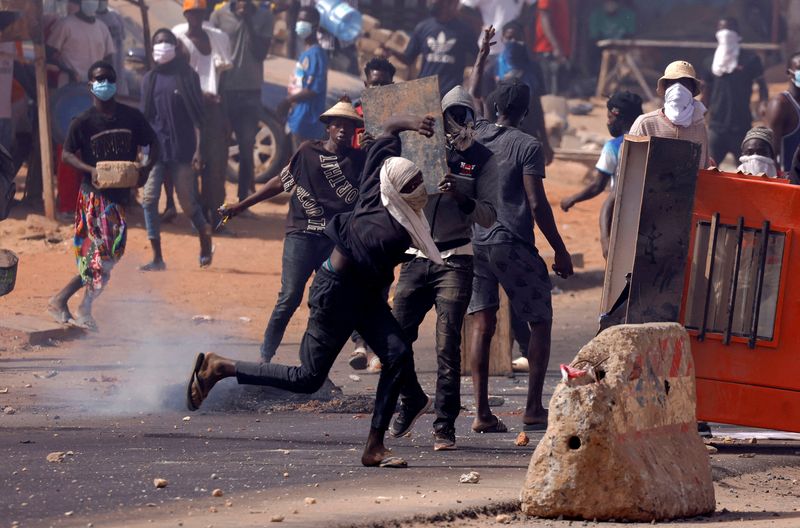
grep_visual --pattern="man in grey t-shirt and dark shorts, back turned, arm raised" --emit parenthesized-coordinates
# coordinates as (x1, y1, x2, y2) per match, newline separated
(467, 78, 572, 433)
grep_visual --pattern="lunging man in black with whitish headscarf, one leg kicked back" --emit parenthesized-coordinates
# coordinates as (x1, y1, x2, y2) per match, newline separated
(187, 116, 442, 467)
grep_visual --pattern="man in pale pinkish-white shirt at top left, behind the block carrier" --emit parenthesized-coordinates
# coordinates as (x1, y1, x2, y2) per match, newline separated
(47, 0, 116, 86)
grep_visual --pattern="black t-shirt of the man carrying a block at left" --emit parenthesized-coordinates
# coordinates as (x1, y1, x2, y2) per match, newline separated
(64, 103, 156, 203)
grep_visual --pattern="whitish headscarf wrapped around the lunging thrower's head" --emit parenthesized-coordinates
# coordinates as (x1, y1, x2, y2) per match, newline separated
(381, 157, 444, 264)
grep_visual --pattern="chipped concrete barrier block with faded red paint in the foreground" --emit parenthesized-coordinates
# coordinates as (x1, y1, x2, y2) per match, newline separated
(522, 323, 715, 521)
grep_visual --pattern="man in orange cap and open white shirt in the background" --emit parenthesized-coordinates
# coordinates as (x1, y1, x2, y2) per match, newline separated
(168, 0, 232, 225)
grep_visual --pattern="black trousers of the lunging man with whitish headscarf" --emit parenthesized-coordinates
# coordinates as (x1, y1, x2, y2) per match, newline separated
(236, 268, 424, 430)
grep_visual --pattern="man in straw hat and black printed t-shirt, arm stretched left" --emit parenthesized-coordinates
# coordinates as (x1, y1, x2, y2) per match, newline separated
(220, 96, 366, 362)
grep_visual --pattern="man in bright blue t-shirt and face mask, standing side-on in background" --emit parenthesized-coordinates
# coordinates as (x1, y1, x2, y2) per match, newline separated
(278, 7, 328, 150)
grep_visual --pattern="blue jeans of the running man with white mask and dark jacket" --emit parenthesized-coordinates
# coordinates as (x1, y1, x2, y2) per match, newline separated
(142, 162, 208, 240)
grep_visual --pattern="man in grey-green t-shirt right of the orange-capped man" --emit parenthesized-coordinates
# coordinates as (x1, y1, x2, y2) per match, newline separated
(211, 0, 273, 201)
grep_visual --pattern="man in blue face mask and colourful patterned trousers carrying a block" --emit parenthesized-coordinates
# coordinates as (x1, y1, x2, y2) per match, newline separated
(47, 61, 160, 330)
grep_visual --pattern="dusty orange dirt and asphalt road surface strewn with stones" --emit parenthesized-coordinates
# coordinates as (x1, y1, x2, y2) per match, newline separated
(0, 97, 800, 527)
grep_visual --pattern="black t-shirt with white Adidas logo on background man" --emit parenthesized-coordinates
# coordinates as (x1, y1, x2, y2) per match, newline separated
(405, 18, 478, 95)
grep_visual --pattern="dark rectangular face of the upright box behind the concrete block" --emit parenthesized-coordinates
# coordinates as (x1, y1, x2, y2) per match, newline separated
(626, 137, 700, 324)
